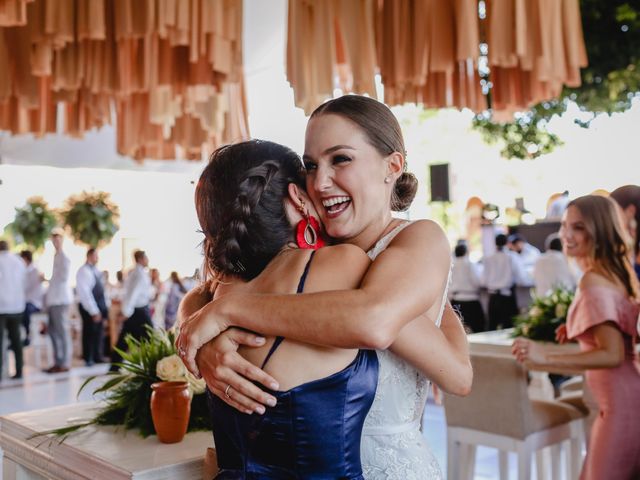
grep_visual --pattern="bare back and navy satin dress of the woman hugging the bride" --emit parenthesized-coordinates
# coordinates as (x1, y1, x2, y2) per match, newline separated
(210, 246, 378, 479)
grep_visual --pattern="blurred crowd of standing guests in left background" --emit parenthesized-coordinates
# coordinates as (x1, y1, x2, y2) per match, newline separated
(0, 229, 199, 381)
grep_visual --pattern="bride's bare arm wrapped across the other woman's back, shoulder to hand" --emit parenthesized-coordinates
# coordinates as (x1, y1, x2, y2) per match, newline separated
(178, 220, 450, 372)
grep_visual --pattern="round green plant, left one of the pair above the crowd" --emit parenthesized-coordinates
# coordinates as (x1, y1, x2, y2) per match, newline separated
(9, 197, 57, 250)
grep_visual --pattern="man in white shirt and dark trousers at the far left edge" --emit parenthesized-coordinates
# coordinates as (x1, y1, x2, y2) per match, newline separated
(0, 240, 27, 380)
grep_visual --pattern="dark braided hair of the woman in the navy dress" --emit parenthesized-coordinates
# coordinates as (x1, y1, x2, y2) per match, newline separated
(195, 140, 304, 280)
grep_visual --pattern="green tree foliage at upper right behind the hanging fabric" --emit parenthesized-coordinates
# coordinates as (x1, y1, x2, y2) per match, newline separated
(473, 0, 640, 159)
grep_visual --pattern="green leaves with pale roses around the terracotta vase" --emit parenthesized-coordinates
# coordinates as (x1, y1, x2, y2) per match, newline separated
(43, 327, 211, 441)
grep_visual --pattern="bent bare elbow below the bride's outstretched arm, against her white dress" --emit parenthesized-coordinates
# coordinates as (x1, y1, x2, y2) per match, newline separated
(390, 302, 473, 396)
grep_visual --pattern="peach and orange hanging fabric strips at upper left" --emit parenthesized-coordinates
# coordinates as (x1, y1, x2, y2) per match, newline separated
(0, 0, 249, 160)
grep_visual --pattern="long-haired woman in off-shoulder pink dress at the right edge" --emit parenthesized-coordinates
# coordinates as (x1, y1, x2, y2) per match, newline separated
(512, 195, 640, 480)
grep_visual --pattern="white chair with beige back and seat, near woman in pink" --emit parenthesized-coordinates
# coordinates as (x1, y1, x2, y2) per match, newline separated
(444, 353, 584, 480)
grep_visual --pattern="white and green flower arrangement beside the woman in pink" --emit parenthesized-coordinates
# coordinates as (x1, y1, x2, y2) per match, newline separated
(513, 288, 573, 342)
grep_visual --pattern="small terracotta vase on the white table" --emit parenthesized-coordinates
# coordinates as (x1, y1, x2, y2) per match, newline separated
(151, 382, 191, 443)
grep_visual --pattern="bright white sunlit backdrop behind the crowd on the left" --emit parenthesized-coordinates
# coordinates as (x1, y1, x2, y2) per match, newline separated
(0, 165, 202, 278)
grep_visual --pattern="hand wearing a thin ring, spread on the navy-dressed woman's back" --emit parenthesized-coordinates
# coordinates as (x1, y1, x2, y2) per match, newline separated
(196, 328, 278, 414)
